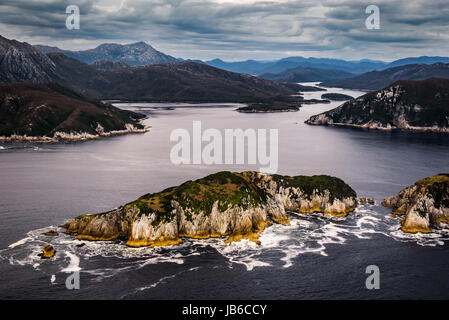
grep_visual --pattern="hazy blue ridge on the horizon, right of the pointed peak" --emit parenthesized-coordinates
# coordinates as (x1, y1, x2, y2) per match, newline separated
(206, 57, 387, 75)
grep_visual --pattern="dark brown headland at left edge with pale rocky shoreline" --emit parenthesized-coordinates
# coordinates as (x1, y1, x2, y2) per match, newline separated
(0, 83, 145, 140)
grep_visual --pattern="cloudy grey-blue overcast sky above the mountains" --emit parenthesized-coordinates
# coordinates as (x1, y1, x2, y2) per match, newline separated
(0, 0, 449, 61)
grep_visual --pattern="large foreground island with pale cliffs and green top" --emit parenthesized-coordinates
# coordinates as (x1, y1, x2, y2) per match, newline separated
(64, 172, 357, 247)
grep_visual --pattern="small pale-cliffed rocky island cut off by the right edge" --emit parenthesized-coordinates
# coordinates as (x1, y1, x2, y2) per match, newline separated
(382, 174, 449, 233)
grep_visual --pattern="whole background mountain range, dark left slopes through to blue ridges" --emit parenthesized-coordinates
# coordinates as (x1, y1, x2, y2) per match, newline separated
(4, 36, 449, 102)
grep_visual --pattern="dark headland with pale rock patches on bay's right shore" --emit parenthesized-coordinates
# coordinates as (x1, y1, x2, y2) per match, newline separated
(306, 78, 449, 133)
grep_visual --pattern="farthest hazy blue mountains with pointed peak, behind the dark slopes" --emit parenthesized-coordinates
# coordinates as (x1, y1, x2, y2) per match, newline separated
(31, 38, 449, 86)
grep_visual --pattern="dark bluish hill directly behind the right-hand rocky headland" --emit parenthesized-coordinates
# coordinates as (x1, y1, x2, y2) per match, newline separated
(322, 63, 449, 90)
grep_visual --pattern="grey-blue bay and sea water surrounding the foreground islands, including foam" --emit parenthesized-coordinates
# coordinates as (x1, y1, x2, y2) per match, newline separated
(0, 89, 449, 299)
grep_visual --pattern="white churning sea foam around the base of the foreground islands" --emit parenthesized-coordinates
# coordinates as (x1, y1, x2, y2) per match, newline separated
(0, 205, 449, 281)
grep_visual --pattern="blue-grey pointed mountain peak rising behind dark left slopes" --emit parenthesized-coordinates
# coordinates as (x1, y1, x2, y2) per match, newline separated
(34, 42, 178, 66)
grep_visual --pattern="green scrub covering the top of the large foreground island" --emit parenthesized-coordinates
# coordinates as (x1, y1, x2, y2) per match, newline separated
(110, 171, 356, 225)
